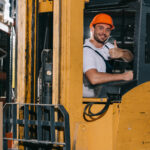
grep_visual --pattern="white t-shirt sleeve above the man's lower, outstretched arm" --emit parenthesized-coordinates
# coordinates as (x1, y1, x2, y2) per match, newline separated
(83, 48, 96, 73)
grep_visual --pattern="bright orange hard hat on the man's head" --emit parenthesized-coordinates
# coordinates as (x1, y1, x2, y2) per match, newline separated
(90, 13, 115, 30)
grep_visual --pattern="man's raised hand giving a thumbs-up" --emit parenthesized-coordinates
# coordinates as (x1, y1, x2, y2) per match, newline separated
(109, 40, 123, 59)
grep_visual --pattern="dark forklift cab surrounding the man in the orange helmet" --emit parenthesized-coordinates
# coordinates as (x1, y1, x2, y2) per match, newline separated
(84, 0, 150, 100)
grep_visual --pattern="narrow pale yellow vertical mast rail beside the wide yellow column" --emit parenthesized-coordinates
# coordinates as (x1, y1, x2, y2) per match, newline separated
(52, 0, 61, 104)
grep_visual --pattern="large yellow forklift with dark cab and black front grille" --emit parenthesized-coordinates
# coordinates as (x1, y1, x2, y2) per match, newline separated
(3, 0, 150, 150)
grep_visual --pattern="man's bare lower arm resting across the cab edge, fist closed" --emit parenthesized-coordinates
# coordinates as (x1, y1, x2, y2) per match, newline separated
(85, 69, 133, 85)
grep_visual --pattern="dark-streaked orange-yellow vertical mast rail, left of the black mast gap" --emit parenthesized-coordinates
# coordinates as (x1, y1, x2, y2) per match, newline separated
(25, 0, 37, 103)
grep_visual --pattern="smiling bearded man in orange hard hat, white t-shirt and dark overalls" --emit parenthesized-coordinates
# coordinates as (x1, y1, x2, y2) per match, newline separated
(83, 13, 133, 97)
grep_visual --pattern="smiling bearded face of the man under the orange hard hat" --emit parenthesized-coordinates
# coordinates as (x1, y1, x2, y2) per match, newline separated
(92, 24, 111, 44)
